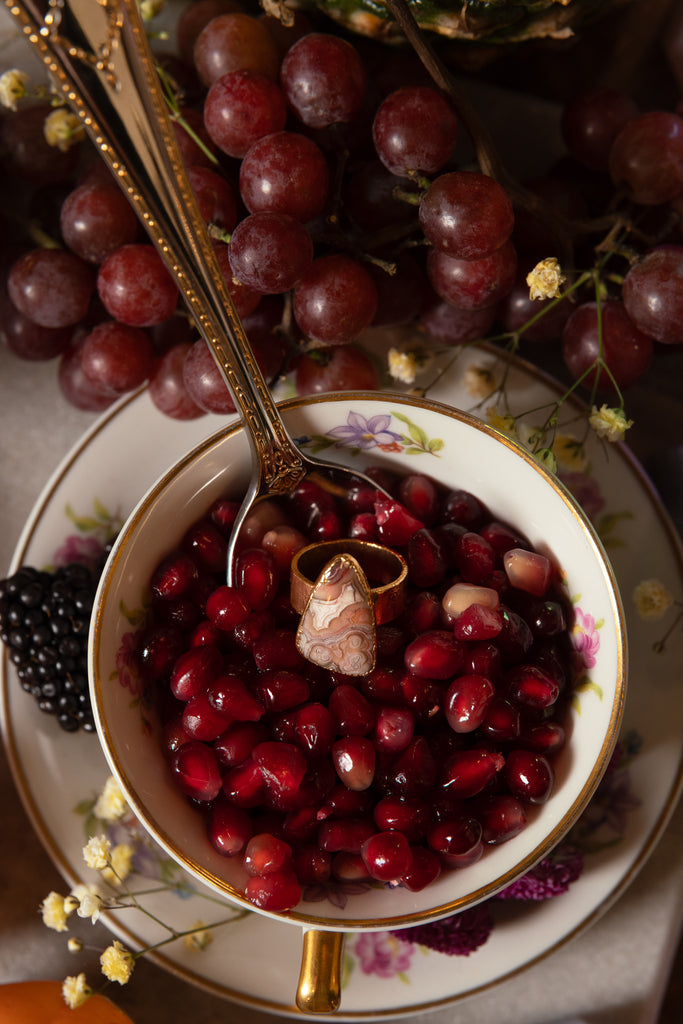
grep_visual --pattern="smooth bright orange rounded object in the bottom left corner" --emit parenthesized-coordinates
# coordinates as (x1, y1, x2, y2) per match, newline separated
(0, 981, 133, 1024)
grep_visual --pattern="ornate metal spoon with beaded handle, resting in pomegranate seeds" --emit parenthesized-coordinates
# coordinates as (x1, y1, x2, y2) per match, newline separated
(9, 0, 389, 584)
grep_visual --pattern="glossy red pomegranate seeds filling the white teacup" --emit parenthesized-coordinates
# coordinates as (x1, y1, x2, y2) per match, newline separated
(129, 471, 572, 911)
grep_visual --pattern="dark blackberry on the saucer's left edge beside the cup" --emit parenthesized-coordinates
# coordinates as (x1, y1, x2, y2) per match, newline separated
(0, 562, 99, 732)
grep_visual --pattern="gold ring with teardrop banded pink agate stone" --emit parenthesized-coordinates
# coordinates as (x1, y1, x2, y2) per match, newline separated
(291, 540, 408, 676)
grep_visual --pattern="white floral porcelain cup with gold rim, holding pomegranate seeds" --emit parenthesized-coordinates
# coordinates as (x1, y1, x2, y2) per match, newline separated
(89, 393, 627, 1007)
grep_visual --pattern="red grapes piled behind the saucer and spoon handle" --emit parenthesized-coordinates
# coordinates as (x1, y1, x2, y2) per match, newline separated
(0, 0, 683, 419)
